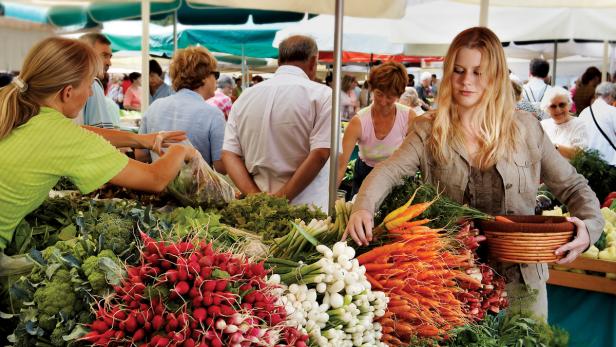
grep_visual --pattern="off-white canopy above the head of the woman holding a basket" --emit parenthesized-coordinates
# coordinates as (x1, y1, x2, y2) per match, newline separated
(398, 0, 616, 54)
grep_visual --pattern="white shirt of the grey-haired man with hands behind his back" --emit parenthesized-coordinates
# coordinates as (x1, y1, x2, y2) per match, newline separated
(223, 65, 332, 211)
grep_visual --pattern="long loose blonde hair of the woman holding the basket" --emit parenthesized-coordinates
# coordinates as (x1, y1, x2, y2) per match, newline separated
(428, 27, 519, 170)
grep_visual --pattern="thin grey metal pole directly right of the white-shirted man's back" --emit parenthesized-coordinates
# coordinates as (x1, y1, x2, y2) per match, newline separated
(328, 0, 344, 216)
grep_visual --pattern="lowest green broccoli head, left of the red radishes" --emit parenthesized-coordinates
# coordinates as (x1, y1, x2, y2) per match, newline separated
(34, 269, 77, 316)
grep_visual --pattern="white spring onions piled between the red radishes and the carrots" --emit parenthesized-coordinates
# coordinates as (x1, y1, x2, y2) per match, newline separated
(268, 242, 388, 347)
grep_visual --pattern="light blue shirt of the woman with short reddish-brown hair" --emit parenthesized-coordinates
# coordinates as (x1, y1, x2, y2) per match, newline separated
(139, 89, 225, 166)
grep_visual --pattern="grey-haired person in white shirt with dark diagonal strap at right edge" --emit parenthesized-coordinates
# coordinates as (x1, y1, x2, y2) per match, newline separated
(580, 82, 616, 165)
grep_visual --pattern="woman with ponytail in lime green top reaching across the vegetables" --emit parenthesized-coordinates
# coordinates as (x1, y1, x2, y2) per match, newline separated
(0, 37, 196, 250)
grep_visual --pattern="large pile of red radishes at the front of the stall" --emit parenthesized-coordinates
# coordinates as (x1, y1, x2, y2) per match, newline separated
(83, 234, 308, 347)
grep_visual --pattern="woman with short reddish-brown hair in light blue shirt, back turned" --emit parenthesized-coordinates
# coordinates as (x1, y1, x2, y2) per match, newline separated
(139, 46, 226, 174)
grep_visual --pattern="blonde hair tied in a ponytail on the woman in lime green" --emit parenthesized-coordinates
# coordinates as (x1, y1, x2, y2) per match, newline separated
(0, 37, 101, 140)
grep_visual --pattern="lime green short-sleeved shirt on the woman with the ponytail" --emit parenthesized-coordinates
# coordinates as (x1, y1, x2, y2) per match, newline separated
(0, 107, 128, 249)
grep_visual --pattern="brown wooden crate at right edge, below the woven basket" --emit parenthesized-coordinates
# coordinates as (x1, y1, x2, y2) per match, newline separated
(548, 257, 616, 295)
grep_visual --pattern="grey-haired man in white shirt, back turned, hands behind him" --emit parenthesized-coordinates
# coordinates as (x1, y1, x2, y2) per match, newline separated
(222, 35, 332, 211)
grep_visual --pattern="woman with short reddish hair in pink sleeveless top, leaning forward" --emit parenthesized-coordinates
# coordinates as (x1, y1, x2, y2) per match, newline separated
(338, 62, 415, 194)
